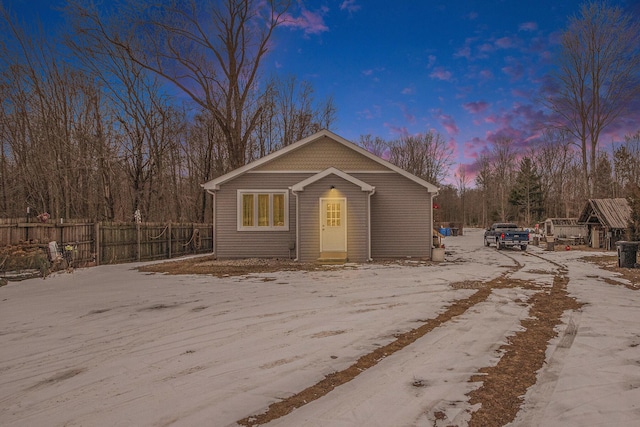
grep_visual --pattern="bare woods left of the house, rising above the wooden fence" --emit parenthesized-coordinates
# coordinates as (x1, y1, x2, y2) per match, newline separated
(0, 0, 335, 221)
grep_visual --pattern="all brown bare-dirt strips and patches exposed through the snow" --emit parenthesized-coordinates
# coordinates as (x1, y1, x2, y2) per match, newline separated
(140, 252, 596, 426)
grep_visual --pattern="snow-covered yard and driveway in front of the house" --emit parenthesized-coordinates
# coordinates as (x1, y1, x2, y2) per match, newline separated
(0, 230, 640, 426)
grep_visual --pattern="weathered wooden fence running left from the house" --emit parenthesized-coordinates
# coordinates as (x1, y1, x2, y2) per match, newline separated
(0, 220, 213, 265)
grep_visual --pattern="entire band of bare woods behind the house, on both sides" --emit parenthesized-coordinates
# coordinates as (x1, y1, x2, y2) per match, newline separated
(0, 0, 640, 229)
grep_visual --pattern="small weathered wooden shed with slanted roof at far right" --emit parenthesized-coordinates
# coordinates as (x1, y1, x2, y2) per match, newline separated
(578, 198, 631, 250)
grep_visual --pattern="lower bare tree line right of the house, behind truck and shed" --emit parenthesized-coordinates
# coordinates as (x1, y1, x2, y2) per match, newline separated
(436, 131, 640, 227)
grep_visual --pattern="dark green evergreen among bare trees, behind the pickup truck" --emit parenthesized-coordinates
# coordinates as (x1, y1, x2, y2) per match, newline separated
(509, 157, 544, 225)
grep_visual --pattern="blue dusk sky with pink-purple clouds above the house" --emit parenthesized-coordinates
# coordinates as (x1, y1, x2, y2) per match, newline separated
(5, 0, 640, 177)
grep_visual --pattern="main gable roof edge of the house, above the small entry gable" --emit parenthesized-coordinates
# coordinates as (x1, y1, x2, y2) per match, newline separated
(202, 129, 438, 193)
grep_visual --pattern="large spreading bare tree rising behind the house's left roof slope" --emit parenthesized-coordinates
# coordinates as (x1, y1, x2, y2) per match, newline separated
(69, 0, 289, 169)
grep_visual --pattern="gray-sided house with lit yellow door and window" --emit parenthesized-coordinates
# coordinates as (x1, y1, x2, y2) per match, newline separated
(203, 130, 438, 262)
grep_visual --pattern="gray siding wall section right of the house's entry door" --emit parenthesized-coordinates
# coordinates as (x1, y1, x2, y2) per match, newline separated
(352, 173, 433, 259)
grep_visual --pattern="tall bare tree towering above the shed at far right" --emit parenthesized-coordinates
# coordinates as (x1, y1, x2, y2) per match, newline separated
(545, 2, 640, 196)
